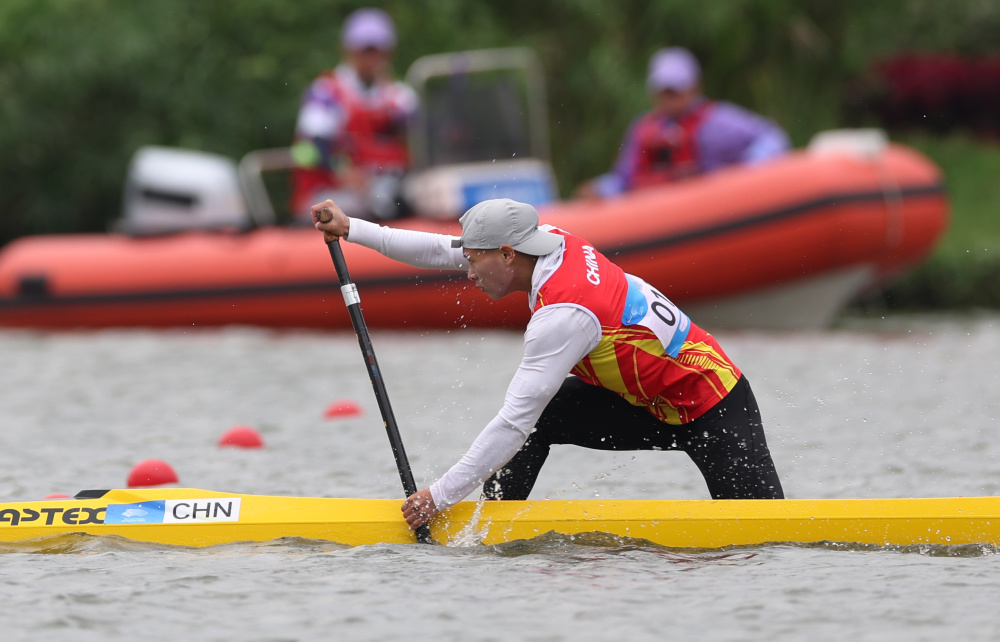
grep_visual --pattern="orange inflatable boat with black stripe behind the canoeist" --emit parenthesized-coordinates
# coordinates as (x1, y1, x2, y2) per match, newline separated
(0, 145, 947, 329)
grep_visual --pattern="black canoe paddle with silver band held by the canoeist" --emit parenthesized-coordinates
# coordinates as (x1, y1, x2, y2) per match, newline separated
(318, 209, 435, 544)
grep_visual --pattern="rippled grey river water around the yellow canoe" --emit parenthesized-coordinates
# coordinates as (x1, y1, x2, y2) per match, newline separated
(0, 315, 1000, 641)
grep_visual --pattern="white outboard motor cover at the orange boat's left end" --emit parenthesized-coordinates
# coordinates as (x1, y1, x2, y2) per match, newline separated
(117, 147, 250, 235)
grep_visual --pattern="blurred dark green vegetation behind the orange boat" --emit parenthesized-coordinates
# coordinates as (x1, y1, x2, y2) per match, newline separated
(0, 0, 1000, 307)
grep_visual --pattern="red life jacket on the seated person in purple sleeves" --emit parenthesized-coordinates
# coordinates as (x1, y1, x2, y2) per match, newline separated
(631, 100, 713, 187)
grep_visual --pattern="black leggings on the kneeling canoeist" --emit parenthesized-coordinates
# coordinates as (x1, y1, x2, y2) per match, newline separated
(483, 377, 784, 499)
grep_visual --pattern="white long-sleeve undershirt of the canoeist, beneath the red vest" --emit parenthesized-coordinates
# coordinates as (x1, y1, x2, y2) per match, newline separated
(347, 218, 601, 510)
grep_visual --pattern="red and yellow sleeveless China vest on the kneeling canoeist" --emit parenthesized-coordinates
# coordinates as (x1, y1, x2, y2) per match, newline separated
(532, 229, 740, 424)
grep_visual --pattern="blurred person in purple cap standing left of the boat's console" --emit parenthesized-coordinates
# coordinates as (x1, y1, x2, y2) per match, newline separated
(291, 9, 417, 220)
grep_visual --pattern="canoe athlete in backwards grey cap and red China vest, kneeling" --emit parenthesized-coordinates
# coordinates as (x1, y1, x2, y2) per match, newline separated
(312, 199, 784, 528)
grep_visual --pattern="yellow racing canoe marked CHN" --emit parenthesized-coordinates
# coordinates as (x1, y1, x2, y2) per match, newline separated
(0, 488, 1000, 548)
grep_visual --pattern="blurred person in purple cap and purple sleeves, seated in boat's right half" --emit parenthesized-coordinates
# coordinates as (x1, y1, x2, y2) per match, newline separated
(577, 47, 789, 198)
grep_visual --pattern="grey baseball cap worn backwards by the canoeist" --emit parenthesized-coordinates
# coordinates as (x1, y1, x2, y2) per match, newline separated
(451, 198, 562, 256)
